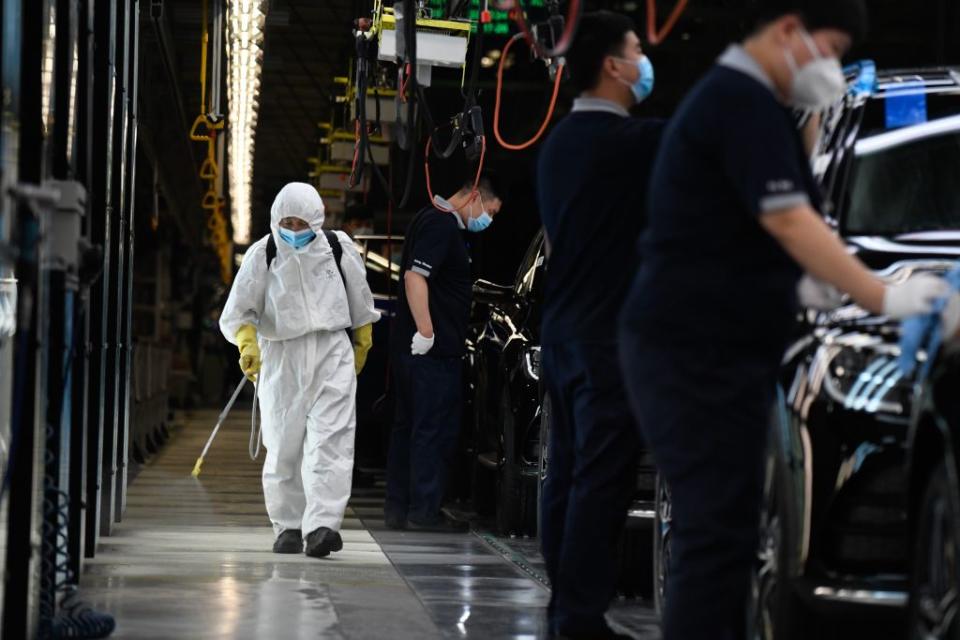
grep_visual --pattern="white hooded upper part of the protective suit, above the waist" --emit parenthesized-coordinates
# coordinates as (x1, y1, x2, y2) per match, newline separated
(220, 182, 380, 343)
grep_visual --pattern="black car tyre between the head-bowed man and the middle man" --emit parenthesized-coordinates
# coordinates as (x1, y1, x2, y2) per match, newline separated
(496, 390, 539, 536)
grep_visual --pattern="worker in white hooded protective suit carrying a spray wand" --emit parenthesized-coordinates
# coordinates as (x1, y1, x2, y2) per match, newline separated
(220, 182, 380, 558)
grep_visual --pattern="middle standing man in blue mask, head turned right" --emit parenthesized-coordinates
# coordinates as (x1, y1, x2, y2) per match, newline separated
(537, 12, 663, 639)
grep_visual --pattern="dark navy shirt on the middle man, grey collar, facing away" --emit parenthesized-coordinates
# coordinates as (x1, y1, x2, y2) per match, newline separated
(537, 98, 663, 345)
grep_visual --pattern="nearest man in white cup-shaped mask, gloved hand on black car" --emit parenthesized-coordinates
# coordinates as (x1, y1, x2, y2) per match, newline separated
(620, 0, 956, 640)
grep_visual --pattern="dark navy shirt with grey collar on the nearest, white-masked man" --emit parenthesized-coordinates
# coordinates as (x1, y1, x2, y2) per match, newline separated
(621, 47, 821, 357)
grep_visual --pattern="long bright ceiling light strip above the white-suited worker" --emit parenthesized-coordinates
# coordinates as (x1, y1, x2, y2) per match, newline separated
(227, 0, 266, 245)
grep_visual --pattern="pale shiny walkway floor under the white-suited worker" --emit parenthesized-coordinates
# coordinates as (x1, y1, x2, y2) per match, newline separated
(81, 409, 441, 640)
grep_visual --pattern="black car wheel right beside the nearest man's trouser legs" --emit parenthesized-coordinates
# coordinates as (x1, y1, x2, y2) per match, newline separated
(747, 457, 821, 640)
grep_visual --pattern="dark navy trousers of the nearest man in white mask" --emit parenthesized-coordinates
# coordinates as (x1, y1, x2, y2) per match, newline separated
(621, 332, 779, 640)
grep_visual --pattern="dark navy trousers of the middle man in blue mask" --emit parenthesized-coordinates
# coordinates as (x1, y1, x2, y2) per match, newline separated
(540, 341, 640, 635)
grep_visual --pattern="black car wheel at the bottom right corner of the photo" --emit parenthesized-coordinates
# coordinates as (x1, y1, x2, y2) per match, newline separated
(909, 462, 960, 640)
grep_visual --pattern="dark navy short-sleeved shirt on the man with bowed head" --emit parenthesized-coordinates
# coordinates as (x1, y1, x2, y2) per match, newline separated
(392, 199, 473, 358)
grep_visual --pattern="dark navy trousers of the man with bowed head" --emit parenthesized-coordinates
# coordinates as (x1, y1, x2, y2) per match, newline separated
(385, 353, 463, 524)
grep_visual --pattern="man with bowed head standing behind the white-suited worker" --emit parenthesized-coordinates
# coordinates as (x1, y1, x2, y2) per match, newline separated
(384, 177, 501, 532)
